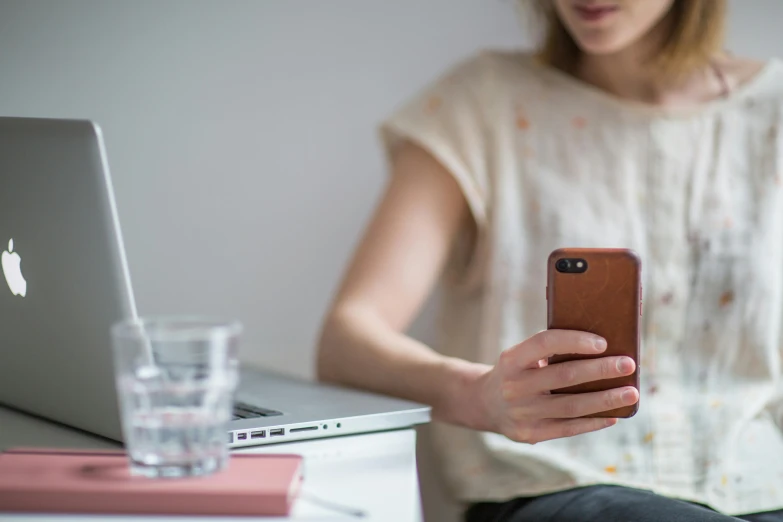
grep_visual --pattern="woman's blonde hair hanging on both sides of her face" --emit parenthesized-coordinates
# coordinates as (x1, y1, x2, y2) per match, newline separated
(521, 0, 727, 80)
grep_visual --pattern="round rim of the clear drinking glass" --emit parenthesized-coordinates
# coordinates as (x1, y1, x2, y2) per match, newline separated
(111, 315, 243, 342)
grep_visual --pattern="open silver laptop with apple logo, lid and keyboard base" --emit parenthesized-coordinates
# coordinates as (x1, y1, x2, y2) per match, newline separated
(0, 118, 430, 447)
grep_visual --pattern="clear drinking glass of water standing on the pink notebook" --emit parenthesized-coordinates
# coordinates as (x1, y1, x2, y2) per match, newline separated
(111, 317, 242, 477)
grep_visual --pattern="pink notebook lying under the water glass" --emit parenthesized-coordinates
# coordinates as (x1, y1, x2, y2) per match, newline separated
(0, 448, 302, 516)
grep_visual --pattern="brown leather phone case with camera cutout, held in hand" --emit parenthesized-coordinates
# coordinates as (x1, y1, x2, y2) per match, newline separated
(547, 248, 642, 418)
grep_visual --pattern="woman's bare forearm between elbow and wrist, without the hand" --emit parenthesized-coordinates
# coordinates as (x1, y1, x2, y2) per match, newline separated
(317, 306, 490, 429)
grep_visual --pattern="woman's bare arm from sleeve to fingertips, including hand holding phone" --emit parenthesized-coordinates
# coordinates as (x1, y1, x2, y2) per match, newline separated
(317, 140, 638, 436)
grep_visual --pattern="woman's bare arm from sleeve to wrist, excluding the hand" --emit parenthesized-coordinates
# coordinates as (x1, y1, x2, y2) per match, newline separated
(317, 138, 488, 428)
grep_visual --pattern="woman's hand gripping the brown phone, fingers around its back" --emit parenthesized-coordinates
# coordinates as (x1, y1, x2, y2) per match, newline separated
(474, 330, 639, 444)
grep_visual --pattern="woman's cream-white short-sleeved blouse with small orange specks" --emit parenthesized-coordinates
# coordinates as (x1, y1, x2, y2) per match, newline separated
(381, 52, 783, 514)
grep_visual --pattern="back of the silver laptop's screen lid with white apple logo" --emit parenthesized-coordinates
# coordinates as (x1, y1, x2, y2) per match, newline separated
(0, 118, 135, 440)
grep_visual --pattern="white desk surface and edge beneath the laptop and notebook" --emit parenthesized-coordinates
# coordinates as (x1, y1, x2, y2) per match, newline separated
(0, 407, 422, 522)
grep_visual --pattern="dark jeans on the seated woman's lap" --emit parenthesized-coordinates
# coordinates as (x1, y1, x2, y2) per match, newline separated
(465, 486, 783, 522)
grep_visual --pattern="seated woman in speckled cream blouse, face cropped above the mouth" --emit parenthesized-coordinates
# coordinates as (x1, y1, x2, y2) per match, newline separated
(318, 0, 783, 522)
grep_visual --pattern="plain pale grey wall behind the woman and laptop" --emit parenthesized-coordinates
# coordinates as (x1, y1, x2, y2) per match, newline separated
(0, 0, 783, 520)
